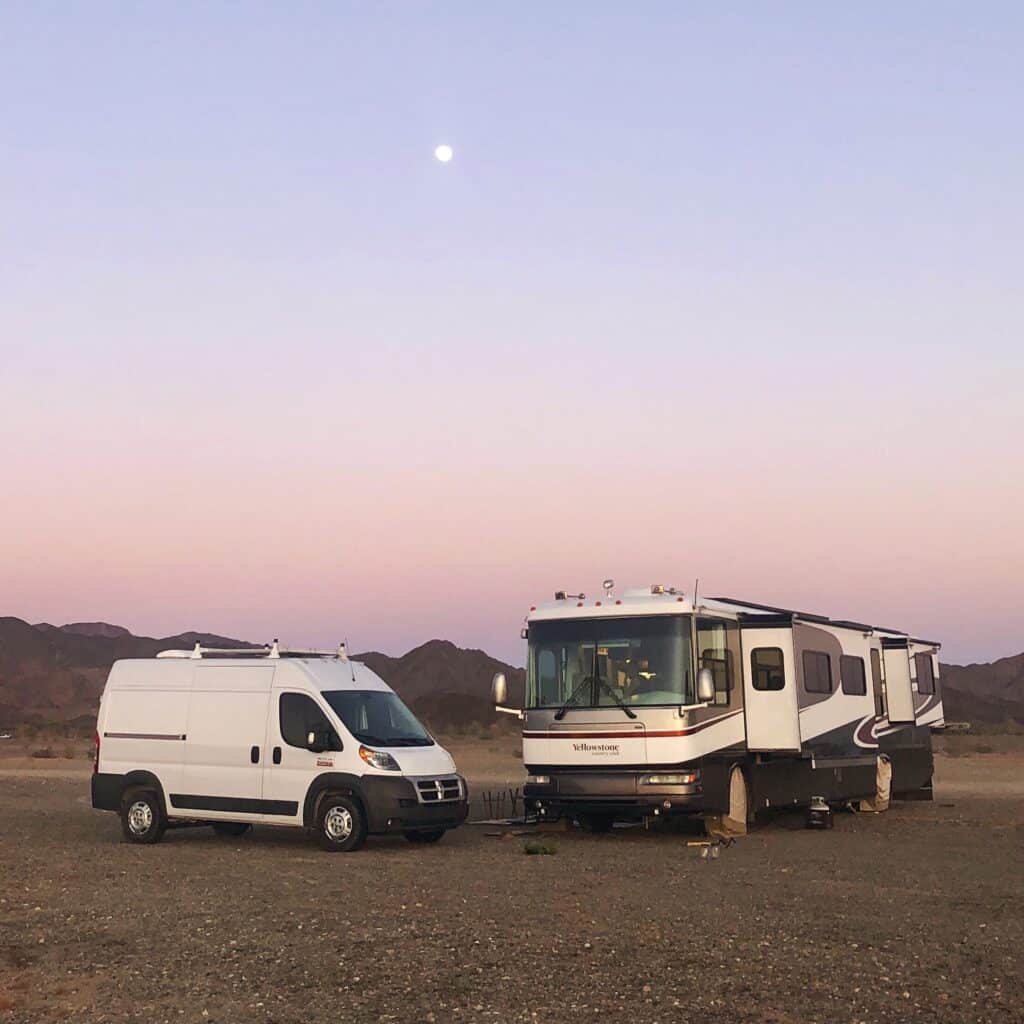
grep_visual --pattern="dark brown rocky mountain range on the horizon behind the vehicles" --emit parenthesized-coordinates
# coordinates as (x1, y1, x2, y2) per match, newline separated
(0, 617, 1024, 731)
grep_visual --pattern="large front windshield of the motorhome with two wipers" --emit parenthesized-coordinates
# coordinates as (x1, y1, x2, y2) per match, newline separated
(526, 615, 693, 708)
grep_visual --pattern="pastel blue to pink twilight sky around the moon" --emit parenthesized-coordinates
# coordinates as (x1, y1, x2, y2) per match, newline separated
(0, 2, 1024, 663)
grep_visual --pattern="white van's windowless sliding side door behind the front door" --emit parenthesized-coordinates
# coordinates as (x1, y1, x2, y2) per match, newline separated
(175, 665, 274, 820)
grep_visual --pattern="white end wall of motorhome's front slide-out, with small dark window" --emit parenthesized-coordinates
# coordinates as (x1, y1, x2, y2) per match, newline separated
(740, 626, 800, 753)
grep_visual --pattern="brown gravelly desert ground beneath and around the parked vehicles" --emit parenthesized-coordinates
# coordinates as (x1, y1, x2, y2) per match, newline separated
(0, 736, 1024, 1024)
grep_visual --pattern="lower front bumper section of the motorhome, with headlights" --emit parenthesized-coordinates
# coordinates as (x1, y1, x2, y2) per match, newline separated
(523, 768, 705, 817)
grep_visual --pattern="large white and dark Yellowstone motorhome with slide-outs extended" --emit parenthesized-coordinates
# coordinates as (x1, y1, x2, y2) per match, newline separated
(494, 581, 943, 830)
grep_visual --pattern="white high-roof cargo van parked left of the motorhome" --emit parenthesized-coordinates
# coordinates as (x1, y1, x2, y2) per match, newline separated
(92, 641, 468, 851)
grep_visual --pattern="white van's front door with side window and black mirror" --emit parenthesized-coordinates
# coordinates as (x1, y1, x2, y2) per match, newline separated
(263, 690, 344, 824)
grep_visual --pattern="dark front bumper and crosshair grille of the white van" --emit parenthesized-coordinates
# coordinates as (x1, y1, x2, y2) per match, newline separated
(361, 775, 469, 833)
